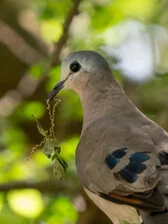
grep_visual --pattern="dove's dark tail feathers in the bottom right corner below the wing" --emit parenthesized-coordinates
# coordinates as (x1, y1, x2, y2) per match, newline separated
(141, 211, 168, 224)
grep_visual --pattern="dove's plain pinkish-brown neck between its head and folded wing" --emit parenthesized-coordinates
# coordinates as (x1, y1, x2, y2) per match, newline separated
(79, 76, 132, 131)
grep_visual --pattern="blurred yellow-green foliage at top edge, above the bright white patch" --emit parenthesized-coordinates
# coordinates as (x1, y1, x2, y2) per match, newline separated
(91, 0, 156, 32)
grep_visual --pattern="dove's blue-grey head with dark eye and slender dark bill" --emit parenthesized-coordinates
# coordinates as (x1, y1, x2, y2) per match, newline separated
(48, 51, 111, 100)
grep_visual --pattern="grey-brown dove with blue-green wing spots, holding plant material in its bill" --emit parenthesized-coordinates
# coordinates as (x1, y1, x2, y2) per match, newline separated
(48, 50, 168, 224)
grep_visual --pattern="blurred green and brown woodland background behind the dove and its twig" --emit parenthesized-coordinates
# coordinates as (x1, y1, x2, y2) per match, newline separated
(0, 0, 168, 224)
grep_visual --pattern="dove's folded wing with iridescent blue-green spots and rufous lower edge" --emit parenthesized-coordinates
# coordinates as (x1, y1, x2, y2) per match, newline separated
(77, 118, 164, 211)
